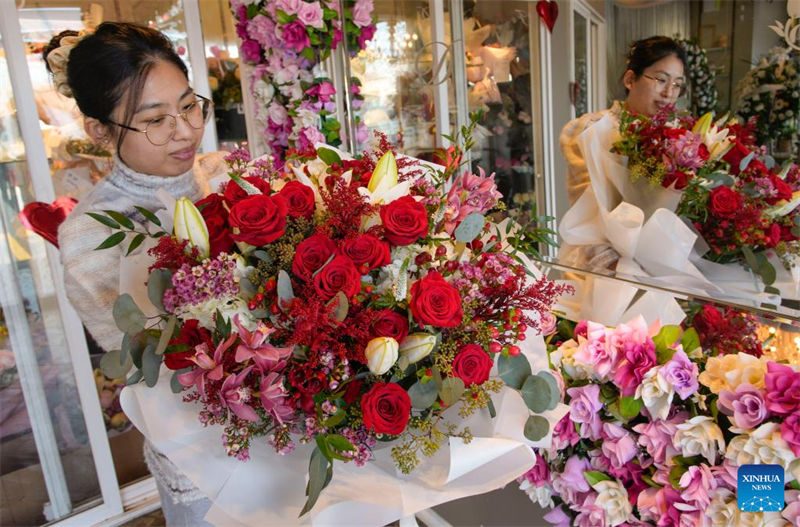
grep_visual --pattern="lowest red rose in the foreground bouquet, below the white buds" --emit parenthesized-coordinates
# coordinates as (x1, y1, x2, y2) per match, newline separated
(361, 382, 411, 435)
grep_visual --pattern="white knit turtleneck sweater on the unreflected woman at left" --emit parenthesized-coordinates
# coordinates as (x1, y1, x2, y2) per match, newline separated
(58, 152, 225, 503)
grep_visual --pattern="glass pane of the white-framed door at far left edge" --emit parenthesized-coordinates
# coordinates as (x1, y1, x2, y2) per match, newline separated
(0, 32, 100, 525)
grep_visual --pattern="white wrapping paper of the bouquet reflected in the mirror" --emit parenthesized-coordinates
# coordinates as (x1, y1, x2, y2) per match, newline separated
(559, 111, 800, 324)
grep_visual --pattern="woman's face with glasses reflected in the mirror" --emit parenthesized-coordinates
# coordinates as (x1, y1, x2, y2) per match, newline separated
(622, 55, 686, 115)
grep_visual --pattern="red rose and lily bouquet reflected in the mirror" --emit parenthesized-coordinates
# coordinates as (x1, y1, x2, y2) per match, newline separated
(613, 108, 800, 286)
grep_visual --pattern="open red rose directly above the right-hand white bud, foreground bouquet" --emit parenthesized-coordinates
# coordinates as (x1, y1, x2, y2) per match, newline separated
(409, 271, 463, 328)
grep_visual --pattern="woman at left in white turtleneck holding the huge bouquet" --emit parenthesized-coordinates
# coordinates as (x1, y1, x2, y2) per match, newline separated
(44, 22, 224, 527)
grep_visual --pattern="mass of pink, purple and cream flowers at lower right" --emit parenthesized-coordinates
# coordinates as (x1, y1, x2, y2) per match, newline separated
(522, 317, 800, 527)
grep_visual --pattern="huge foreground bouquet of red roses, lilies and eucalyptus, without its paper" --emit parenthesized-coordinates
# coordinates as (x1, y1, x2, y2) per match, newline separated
(94, 134, 565, 512)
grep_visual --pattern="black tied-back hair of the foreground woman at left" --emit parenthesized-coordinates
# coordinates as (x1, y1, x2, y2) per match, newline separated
(42, 22, 189, 148)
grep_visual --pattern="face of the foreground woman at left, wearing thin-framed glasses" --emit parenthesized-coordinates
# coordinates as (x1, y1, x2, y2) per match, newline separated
(111, 61, 203, 177)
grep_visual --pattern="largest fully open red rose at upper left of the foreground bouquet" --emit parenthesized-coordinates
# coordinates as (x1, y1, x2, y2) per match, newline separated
(228, 194, 286, 246)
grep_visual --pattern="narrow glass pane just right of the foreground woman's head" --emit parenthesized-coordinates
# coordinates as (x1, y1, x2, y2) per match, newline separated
(200, 0, 247, 151)
